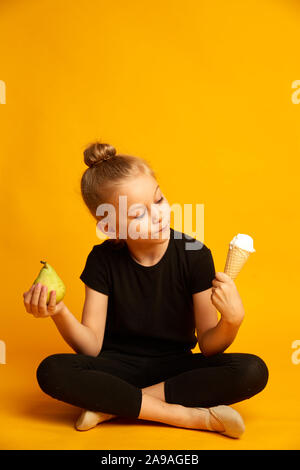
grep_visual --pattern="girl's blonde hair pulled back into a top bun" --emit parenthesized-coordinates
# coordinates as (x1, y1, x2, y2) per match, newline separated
(80, 142, 156, 246)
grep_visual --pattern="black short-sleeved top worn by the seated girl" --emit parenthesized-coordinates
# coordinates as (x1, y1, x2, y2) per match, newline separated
(80, 227, 215, 356)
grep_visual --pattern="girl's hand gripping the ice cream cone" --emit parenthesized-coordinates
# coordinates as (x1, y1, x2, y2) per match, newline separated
(211, 272, 245, 325)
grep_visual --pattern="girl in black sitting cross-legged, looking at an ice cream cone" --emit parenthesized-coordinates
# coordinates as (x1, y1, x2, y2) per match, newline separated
(23, 142, 268, 438)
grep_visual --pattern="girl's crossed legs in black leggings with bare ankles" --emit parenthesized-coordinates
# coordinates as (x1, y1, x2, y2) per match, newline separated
(37, 353, 268, 431)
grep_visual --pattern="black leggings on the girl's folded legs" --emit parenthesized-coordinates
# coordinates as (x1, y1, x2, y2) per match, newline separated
(36, 350, 269, 418)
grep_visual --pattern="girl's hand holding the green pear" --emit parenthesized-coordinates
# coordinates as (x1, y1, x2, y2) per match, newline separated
(23, 282, 65, 318)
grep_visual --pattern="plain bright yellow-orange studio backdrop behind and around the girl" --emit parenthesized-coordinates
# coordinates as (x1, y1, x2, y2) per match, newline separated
(0, 0, 300, 449)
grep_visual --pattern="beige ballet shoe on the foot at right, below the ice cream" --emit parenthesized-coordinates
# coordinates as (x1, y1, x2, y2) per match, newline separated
(197, 405, 245, 439)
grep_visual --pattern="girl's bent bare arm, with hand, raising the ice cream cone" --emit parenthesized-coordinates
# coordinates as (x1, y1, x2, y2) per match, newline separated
(193, 273, 245, 356)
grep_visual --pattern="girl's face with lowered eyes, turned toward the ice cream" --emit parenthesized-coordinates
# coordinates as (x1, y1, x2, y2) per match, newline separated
(98, 175, 170, 243)
